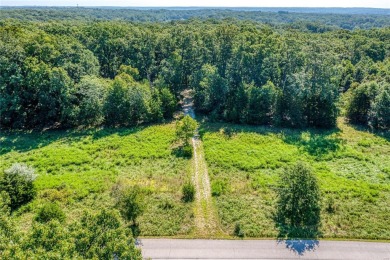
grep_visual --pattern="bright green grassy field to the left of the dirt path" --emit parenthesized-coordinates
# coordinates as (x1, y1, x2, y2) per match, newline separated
(0, 124, 193, 236)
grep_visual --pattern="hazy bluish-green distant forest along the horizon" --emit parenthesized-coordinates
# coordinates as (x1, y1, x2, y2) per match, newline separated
(0, 7, 390, 29)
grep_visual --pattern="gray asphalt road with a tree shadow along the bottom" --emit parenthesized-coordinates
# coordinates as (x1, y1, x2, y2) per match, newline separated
(138, 239, 390, 260)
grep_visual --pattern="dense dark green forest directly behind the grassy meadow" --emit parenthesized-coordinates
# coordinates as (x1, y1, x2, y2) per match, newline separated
(0, 20, 390, 129)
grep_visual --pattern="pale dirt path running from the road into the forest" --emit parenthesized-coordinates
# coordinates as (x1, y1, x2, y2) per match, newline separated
(182, 90, 220, 238)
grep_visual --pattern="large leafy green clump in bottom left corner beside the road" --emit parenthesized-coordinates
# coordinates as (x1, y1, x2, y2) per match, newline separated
(20, 210, 142, 259)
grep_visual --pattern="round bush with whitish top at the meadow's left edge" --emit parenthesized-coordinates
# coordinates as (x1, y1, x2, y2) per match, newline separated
(0, 163, 37, 210)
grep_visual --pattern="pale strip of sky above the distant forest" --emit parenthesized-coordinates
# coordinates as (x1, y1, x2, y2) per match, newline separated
(0, 0, 390, 9)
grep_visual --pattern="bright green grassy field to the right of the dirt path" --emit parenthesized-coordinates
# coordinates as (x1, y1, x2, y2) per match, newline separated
(201, 119, 390, 240)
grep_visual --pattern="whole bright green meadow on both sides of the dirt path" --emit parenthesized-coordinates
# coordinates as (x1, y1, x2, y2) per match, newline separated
(0, 120, 390, 240)
